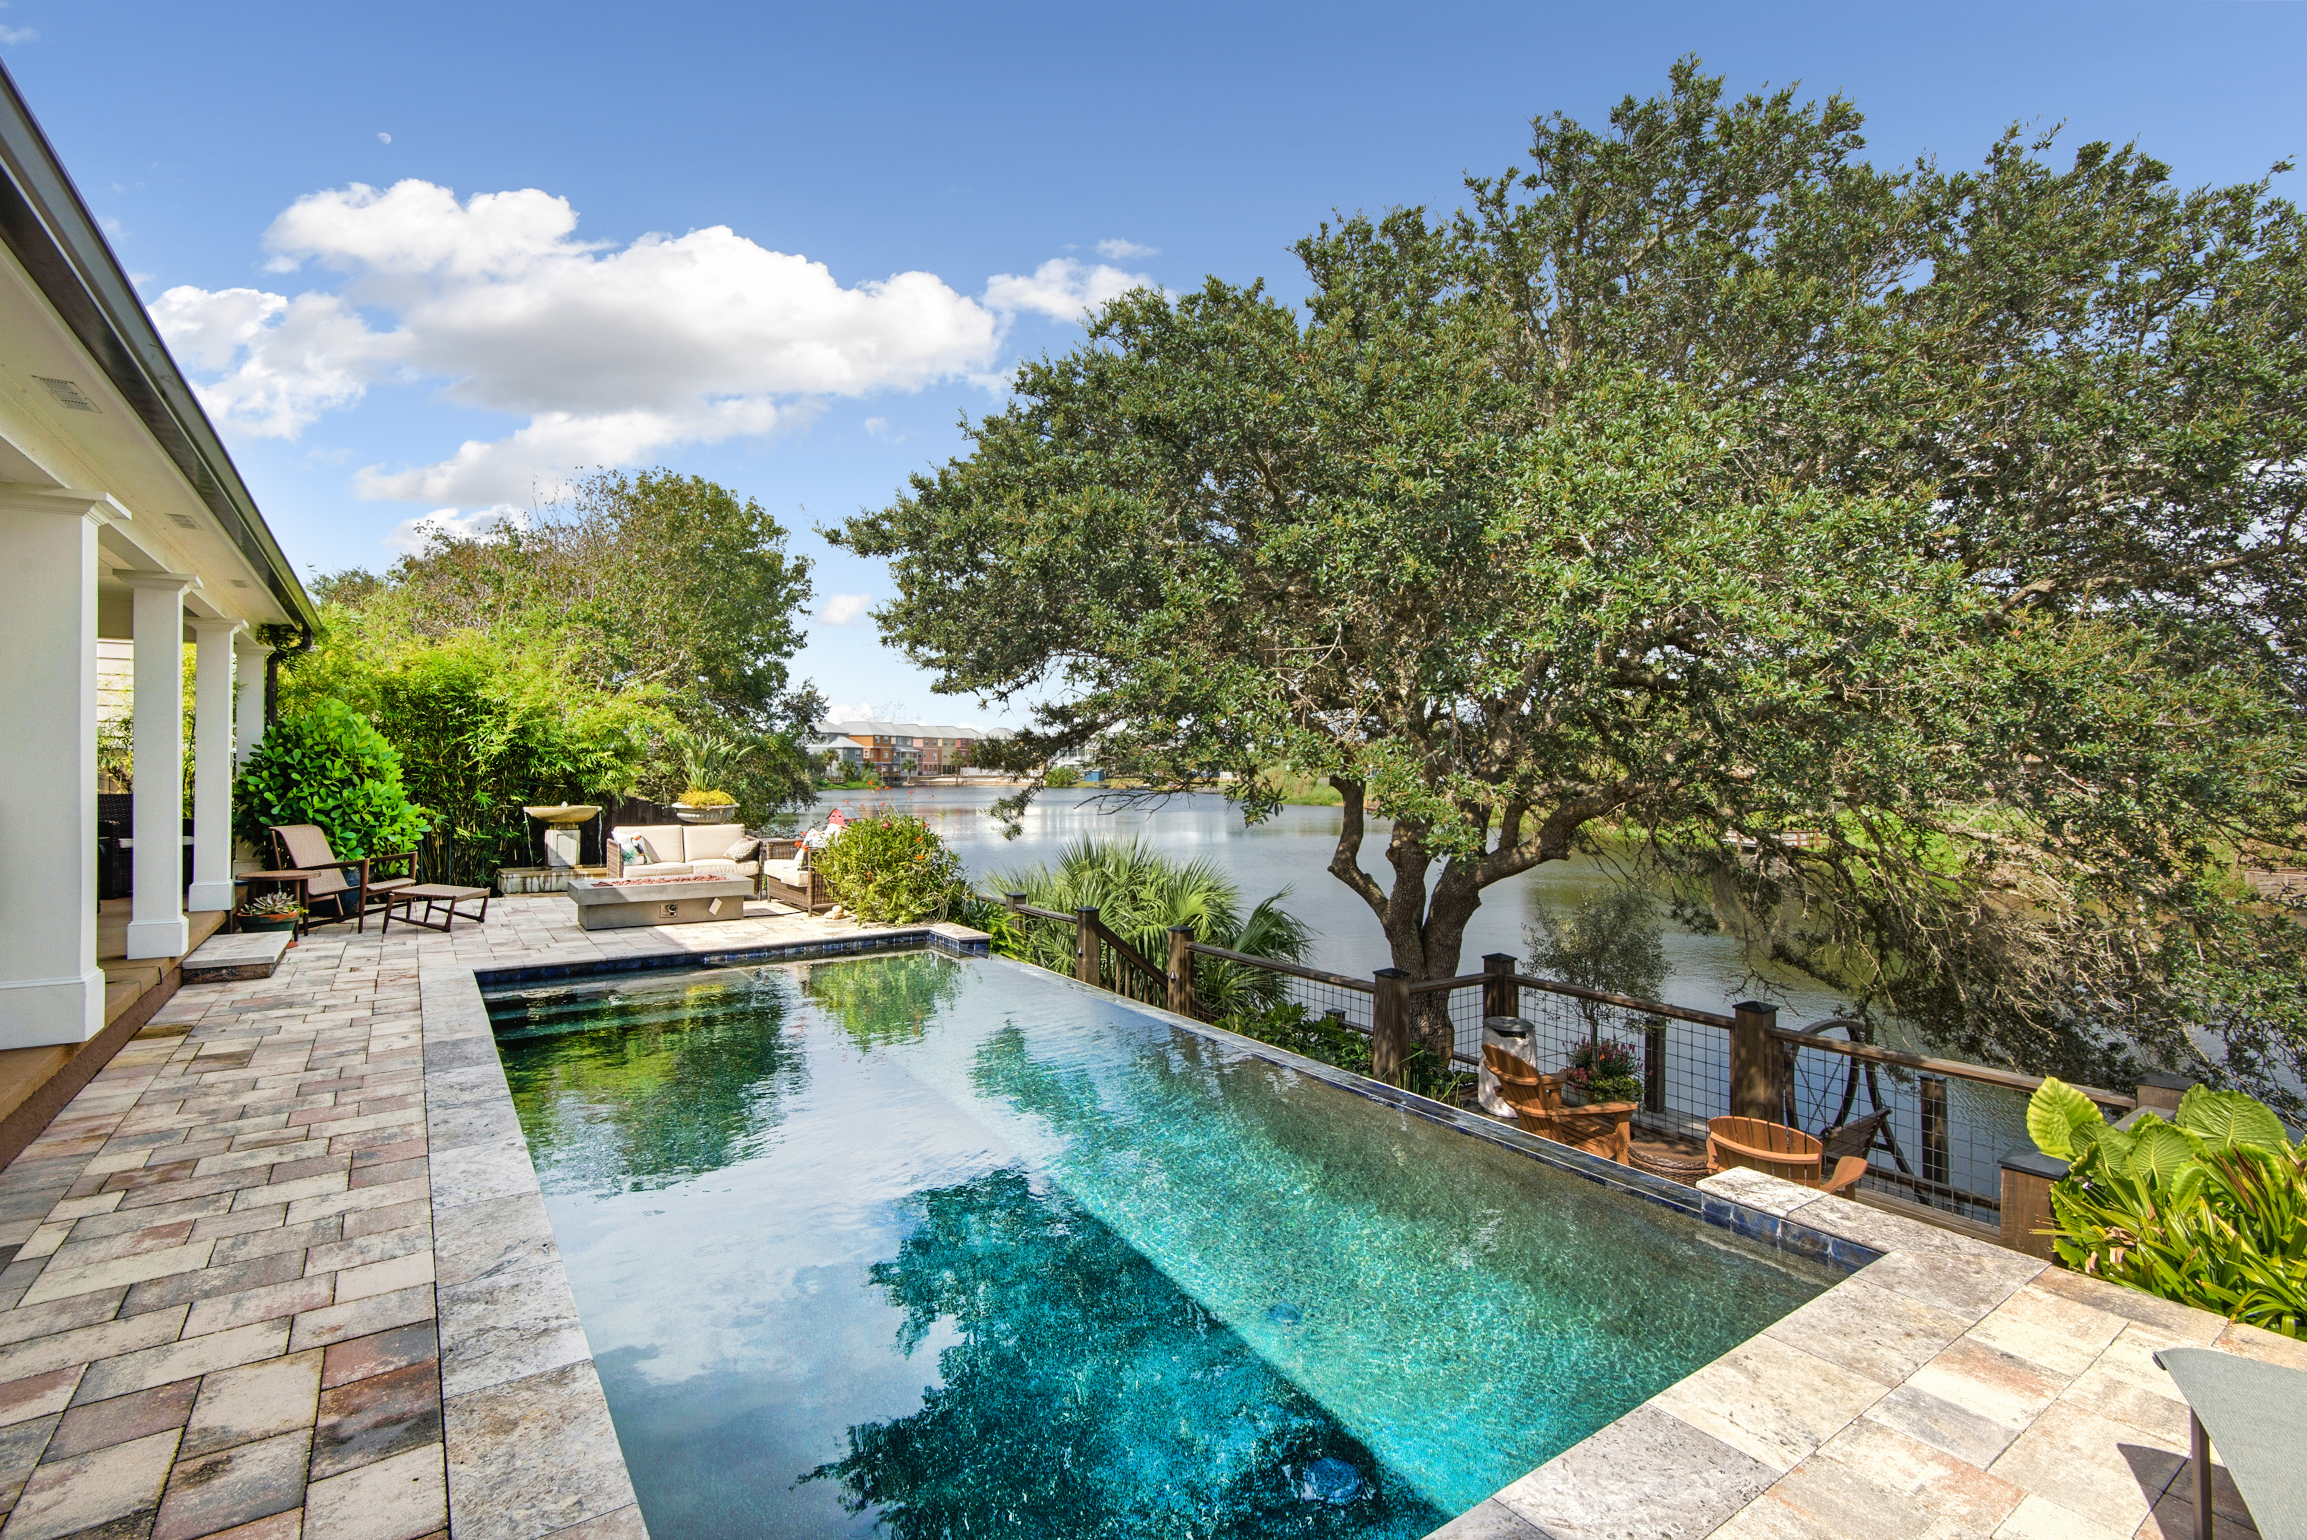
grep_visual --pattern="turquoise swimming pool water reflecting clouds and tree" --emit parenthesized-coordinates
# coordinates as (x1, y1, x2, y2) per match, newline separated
(491, 952, 1832, 1540)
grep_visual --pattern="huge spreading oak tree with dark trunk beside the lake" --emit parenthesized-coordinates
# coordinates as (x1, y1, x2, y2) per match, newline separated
(840, 60, 2307, 1095)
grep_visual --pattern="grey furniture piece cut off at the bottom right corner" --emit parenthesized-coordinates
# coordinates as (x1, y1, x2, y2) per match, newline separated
(2155, 1349, 2307, 1540)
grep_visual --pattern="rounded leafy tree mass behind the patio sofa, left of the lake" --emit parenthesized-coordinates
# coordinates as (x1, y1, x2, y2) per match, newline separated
(284, 470, 821, 881)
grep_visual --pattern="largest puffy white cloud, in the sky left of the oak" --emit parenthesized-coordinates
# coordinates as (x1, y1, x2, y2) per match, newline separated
(152, 180, 1001, 507)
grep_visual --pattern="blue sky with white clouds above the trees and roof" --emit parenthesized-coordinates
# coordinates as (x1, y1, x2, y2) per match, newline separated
(0, 0, 2307, 722)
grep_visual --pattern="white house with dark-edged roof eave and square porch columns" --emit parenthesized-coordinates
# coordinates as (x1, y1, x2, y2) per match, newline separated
(0, 71, 316, 1049)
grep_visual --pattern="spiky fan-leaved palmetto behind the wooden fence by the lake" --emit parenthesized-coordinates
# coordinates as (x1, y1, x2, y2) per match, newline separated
(985, 839, 1313, 1019)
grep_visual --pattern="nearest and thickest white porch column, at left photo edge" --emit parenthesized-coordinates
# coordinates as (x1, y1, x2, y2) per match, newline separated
(0, 489, 127, 1049)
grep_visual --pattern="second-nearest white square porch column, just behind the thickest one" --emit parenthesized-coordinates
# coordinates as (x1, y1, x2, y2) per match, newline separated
(120, 572, 201, 959)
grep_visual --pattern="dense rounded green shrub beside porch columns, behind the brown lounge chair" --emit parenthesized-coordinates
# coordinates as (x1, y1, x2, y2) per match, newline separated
(233, 696, 431, 860)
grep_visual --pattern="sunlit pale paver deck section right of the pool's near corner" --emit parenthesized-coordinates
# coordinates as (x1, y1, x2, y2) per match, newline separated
(1430, 1171, 2307, 1540)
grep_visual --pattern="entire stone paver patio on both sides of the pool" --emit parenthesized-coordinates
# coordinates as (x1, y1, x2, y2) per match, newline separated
(0, 894, 2307, 1540)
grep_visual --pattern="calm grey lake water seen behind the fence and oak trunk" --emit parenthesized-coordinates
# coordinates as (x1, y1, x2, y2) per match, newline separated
(810, 786, 1836, 1026)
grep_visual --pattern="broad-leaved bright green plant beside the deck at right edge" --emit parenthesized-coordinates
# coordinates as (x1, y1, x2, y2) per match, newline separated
(2026, 1079, 2307, 1337)
